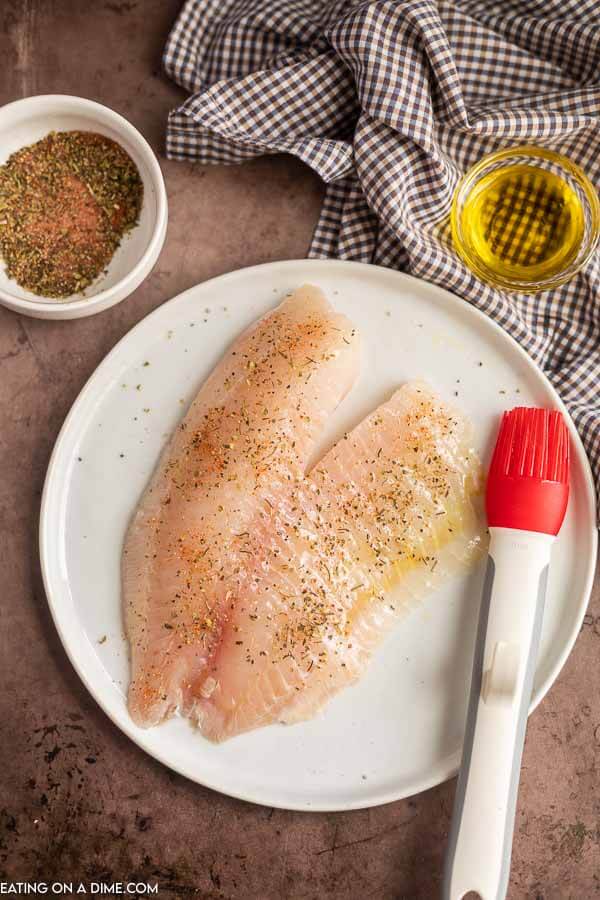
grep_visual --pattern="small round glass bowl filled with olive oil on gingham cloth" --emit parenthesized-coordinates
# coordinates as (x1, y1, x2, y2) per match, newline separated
(450, 146, 600, 293)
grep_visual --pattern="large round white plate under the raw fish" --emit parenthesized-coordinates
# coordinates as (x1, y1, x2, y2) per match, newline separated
(41, 260, 596, 810)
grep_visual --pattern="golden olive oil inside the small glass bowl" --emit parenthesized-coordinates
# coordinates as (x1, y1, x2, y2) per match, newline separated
(460, 164, 585, 282)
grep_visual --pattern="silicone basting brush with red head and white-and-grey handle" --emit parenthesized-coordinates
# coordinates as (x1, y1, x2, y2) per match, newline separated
(443, 408, 569, 900)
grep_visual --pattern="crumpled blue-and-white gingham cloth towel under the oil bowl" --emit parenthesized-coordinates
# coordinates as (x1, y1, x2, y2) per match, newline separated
(164, 0, 600, 506)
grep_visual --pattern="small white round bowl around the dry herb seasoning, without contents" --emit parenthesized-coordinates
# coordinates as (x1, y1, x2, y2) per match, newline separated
(0, 94, 167, 319)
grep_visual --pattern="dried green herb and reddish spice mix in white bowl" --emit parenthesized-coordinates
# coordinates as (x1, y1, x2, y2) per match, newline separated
(0, 131, 143, 297)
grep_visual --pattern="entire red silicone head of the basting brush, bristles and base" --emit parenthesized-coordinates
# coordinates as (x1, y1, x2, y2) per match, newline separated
(486, 406, 569, 534)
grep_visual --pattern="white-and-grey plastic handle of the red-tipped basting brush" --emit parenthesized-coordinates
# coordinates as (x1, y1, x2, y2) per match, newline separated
(443, 528, 554, 900)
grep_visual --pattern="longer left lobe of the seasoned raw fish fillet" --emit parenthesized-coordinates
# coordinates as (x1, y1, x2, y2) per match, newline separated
(122, 286, 360, 739)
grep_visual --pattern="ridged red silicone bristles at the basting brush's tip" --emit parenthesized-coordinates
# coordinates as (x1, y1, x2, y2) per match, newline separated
(490, 406, 569, 484)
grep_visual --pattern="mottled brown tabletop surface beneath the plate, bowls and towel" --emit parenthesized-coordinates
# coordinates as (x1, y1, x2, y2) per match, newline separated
(0, 0, 600, 900)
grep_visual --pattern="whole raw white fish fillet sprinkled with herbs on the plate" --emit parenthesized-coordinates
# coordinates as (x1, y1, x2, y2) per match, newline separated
(123, 287, 482, 741)
